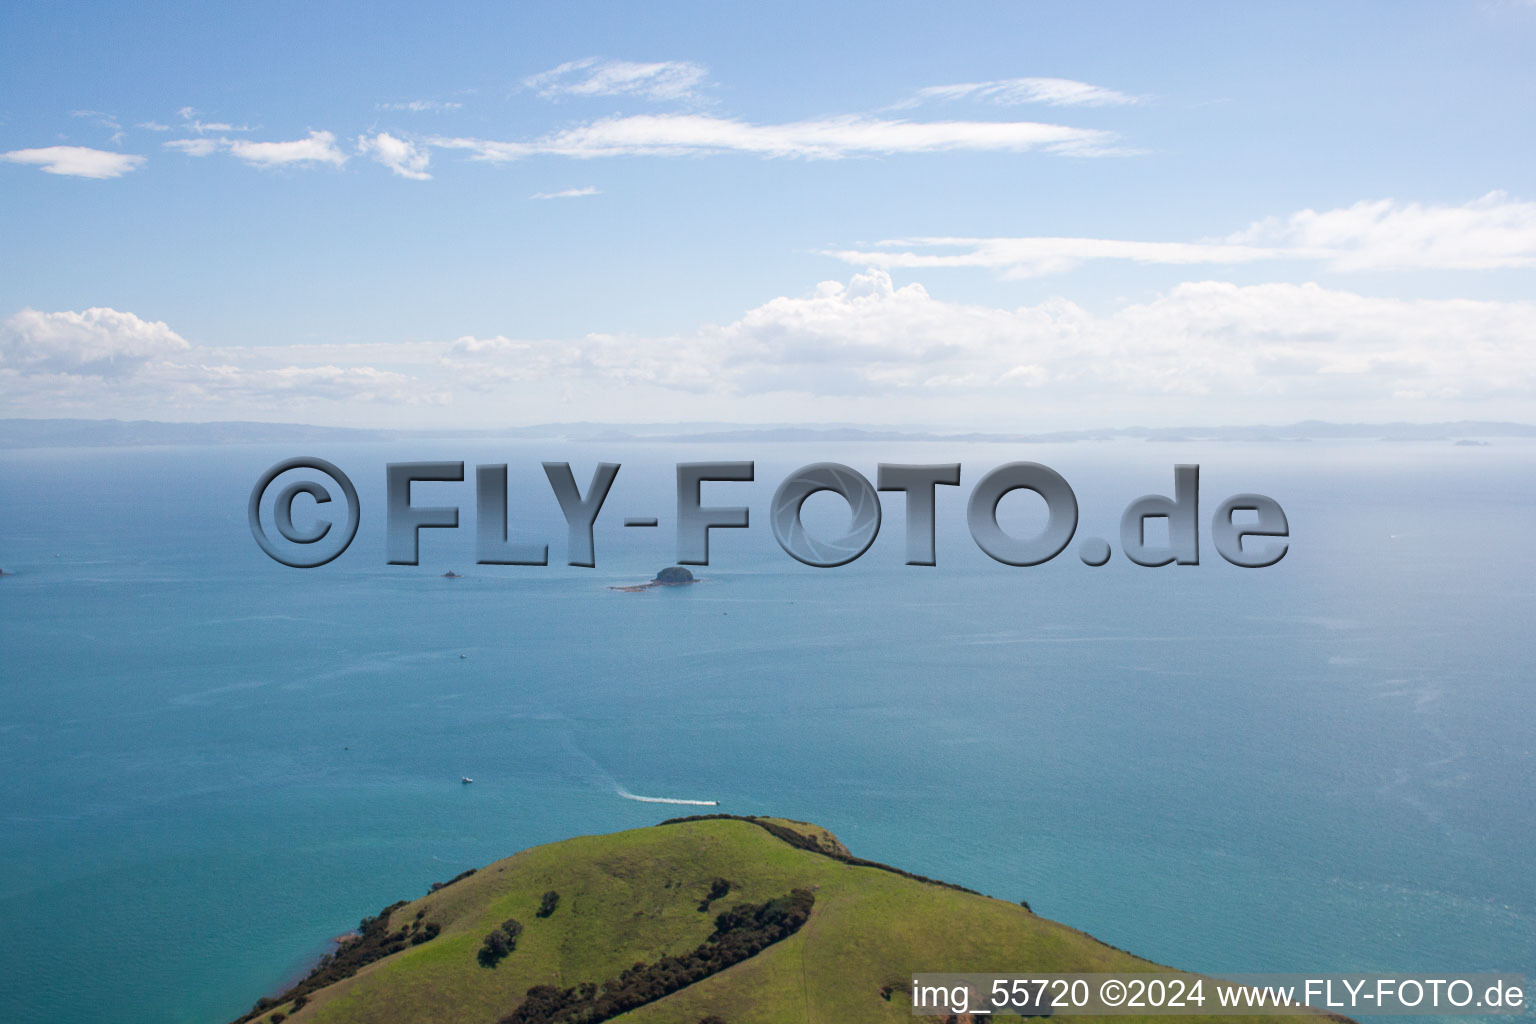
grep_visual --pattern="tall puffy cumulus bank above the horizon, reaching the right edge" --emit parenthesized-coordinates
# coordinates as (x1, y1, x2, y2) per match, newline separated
(445, 270, 1536, 407)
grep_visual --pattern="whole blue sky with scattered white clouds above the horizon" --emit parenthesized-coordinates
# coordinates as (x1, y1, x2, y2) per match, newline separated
(0, 0, 1536, 430)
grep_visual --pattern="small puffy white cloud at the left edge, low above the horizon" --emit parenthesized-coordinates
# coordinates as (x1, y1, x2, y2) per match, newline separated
(0, 307, 190, 376)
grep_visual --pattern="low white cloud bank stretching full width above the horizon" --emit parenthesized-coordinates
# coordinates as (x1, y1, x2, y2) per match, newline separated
(0, 269, 1536, 427)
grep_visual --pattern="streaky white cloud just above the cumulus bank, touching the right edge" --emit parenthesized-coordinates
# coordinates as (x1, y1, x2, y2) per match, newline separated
(825, 192, 1536, 278)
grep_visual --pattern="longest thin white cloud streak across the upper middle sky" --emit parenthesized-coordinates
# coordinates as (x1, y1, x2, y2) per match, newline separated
(432, 114, 1123, 163)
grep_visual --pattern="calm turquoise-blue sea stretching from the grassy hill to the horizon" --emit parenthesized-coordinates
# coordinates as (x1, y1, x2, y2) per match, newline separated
(0, 442, 1536, 1024)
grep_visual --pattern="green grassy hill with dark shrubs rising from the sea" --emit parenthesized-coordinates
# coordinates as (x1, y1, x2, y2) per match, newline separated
(233, 818, 1327, 1024)
